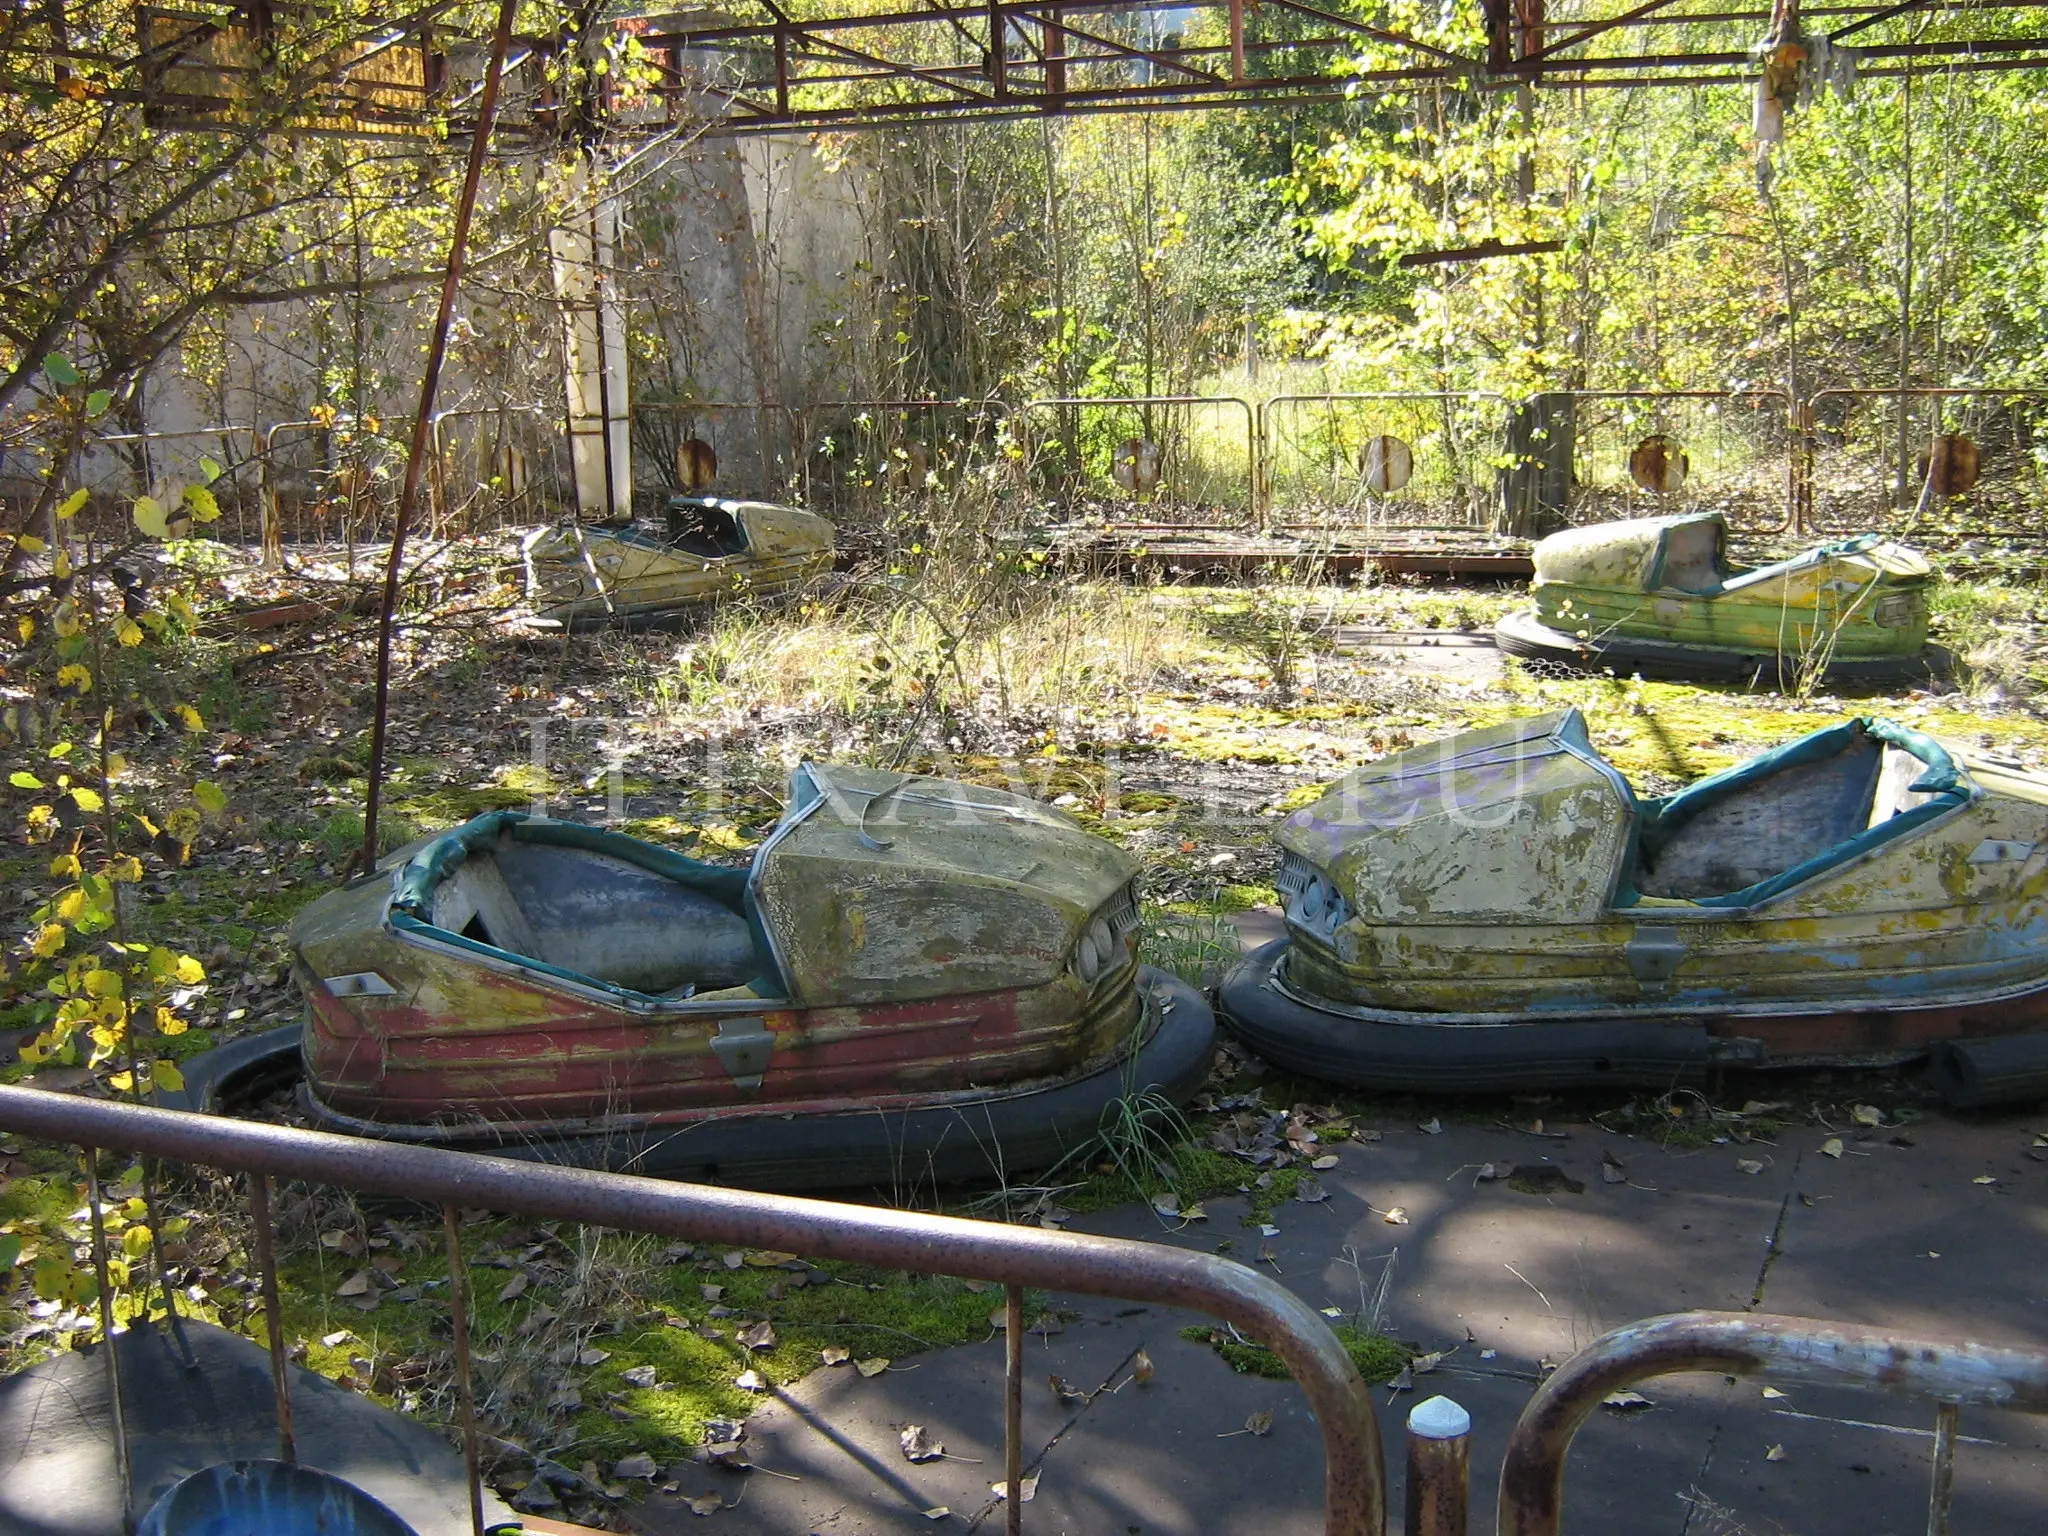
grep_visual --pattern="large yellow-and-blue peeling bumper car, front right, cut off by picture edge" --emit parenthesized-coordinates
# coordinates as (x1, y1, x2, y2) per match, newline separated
(1221, 709, 2048, 1106)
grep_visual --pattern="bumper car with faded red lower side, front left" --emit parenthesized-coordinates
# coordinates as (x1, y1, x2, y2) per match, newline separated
(186, 764, 1214, 1190)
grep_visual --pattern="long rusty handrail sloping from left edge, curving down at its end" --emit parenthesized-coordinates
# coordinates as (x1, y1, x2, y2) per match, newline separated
(0, 1085, 1386, 1536)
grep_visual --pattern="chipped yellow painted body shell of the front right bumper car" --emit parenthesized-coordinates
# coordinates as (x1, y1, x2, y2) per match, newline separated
(1276, 713, 2048, 1016)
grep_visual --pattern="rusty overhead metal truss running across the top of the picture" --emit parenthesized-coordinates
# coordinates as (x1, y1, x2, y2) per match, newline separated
(12, 0, 2048, 139)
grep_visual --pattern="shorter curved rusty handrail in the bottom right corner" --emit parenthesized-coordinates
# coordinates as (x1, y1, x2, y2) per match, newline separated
(1495, 1313, 2048, 1536)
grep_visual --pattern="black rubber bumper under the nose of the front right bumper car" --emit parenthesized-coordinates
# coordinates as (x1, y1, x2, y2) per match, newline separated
(1219, 938, 1712, 1094)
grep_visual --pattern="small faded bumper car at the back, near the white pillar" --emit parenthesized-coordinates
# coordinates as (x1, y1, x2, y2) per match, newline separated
(520, 496, 834, 629)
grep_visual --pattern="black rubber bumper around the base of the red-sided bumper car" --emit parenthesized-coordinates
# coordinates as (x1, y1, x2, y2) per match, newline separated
(167, 969, 1217, 1198)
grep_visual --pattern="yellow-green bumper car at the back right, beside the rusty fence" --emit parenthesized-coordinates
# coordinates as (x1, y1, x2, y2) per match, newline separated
(1493, 512, 1939, 686)
